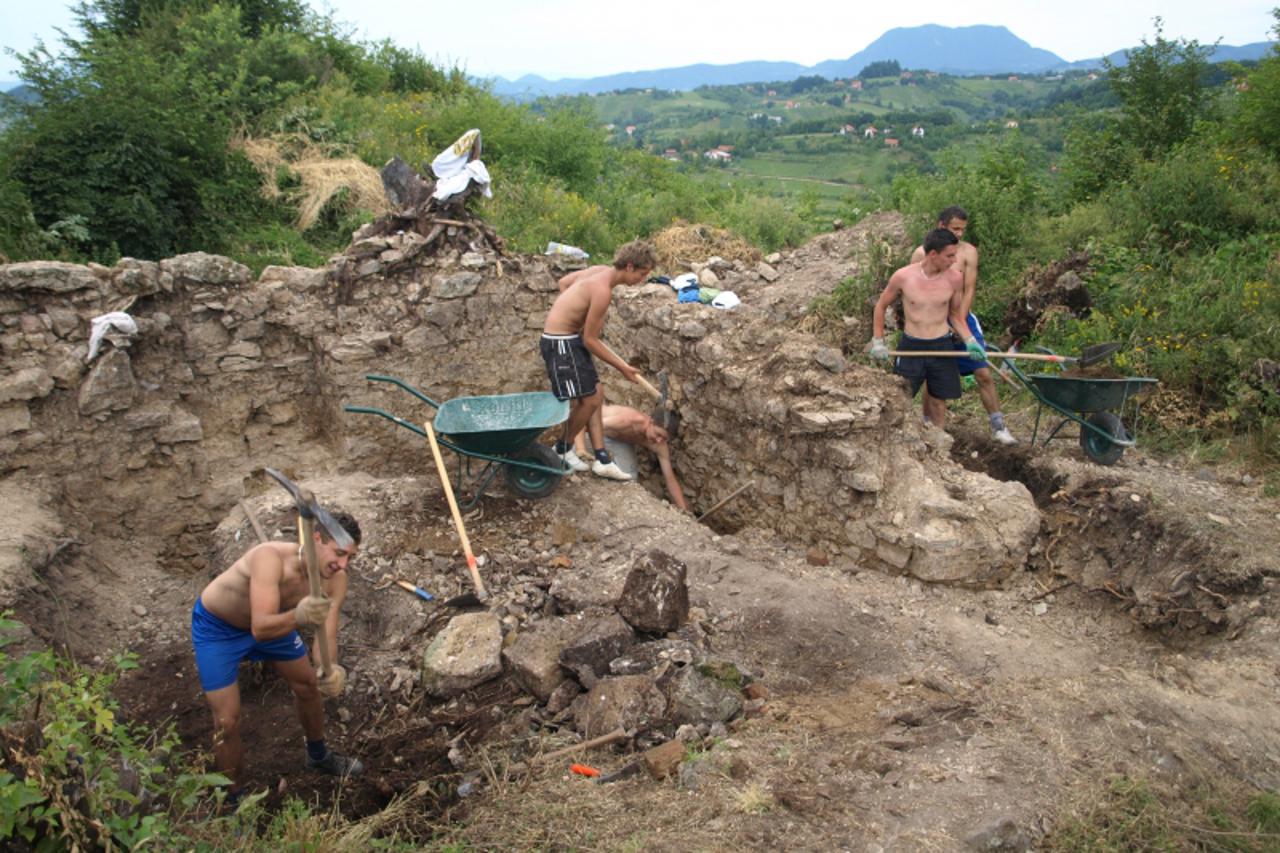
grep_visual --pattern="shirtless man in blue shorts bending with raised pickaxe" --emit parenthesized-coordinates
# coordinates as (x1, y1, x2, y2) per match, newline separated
(191, 512, 364, 804)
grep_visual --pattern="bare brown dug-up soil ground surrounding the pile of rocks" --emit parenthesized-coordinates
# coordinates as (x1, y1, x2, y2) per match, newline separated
(10, 219, 1280, 850)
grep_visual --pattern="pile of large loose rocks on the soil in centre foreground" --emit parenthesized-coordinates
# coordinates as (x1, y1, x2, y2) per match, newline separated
(422, 551, 763, 747)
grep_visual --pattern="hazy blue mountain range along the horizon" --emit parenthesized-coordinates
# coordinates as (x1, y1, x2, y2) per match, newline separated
(490, 24, 1274, 99)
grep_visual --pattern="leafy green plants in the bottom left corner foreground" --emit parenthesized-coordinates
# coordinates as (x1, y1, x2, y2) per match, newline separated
(0, 613, 421, 853)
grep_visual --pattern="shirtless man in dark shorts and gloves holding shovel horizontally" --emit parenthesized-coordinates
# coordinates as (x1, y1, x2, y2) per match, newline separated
(870, 228, 986, 429)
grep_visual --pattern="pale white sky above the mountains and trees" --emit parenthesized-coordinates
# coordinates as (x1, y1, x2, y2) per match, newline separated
(0, 0, 1276, 81)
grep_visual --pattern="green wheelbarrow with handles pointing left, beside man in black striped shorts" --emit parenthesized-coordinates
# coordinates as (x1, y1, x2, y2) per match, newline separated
(343, 374, 568, 510)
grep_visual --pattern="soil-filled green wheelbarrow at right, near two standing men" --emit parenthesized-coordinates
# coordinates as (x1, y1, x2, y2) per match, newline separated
(1005, 361, 1158, 465)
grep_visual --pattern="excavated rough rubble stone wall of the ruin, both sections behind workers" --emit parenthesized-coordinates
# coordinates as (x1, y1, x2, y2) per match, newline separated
(0, 225, 1038, 596)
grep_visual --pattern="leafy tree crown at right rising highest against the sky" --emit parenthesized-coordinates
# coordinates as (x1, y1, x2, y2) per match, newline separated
(1103, 18, 1212, 158)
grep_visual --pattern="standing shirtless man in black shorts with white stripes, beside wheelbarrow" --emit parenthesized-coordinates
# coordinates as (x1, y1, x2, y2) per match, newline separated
(539, 240, 657, 480)
